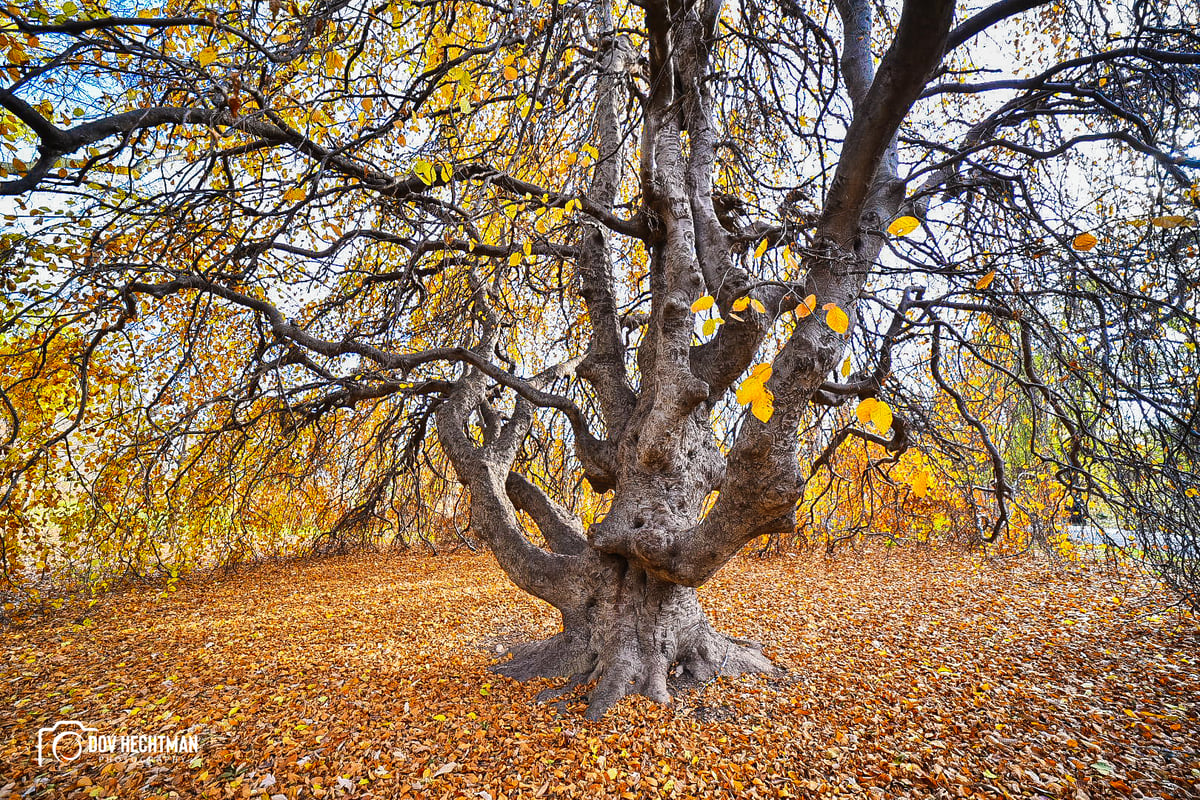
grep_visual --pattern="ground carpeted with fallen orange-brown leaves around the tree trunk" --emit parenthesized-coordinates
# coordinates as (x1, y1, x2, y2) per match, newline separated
(0, 551, 1200, 800)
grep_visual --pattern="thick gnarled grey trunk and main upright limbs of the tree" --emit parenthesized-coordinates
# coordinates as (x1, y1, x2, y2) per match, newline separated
(438, 0, 953, 717)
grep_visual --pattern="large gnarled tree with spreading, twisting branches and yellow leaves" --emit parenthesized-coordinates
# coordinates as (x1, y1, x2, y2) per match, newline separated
(0, 0, 1200, 716)
